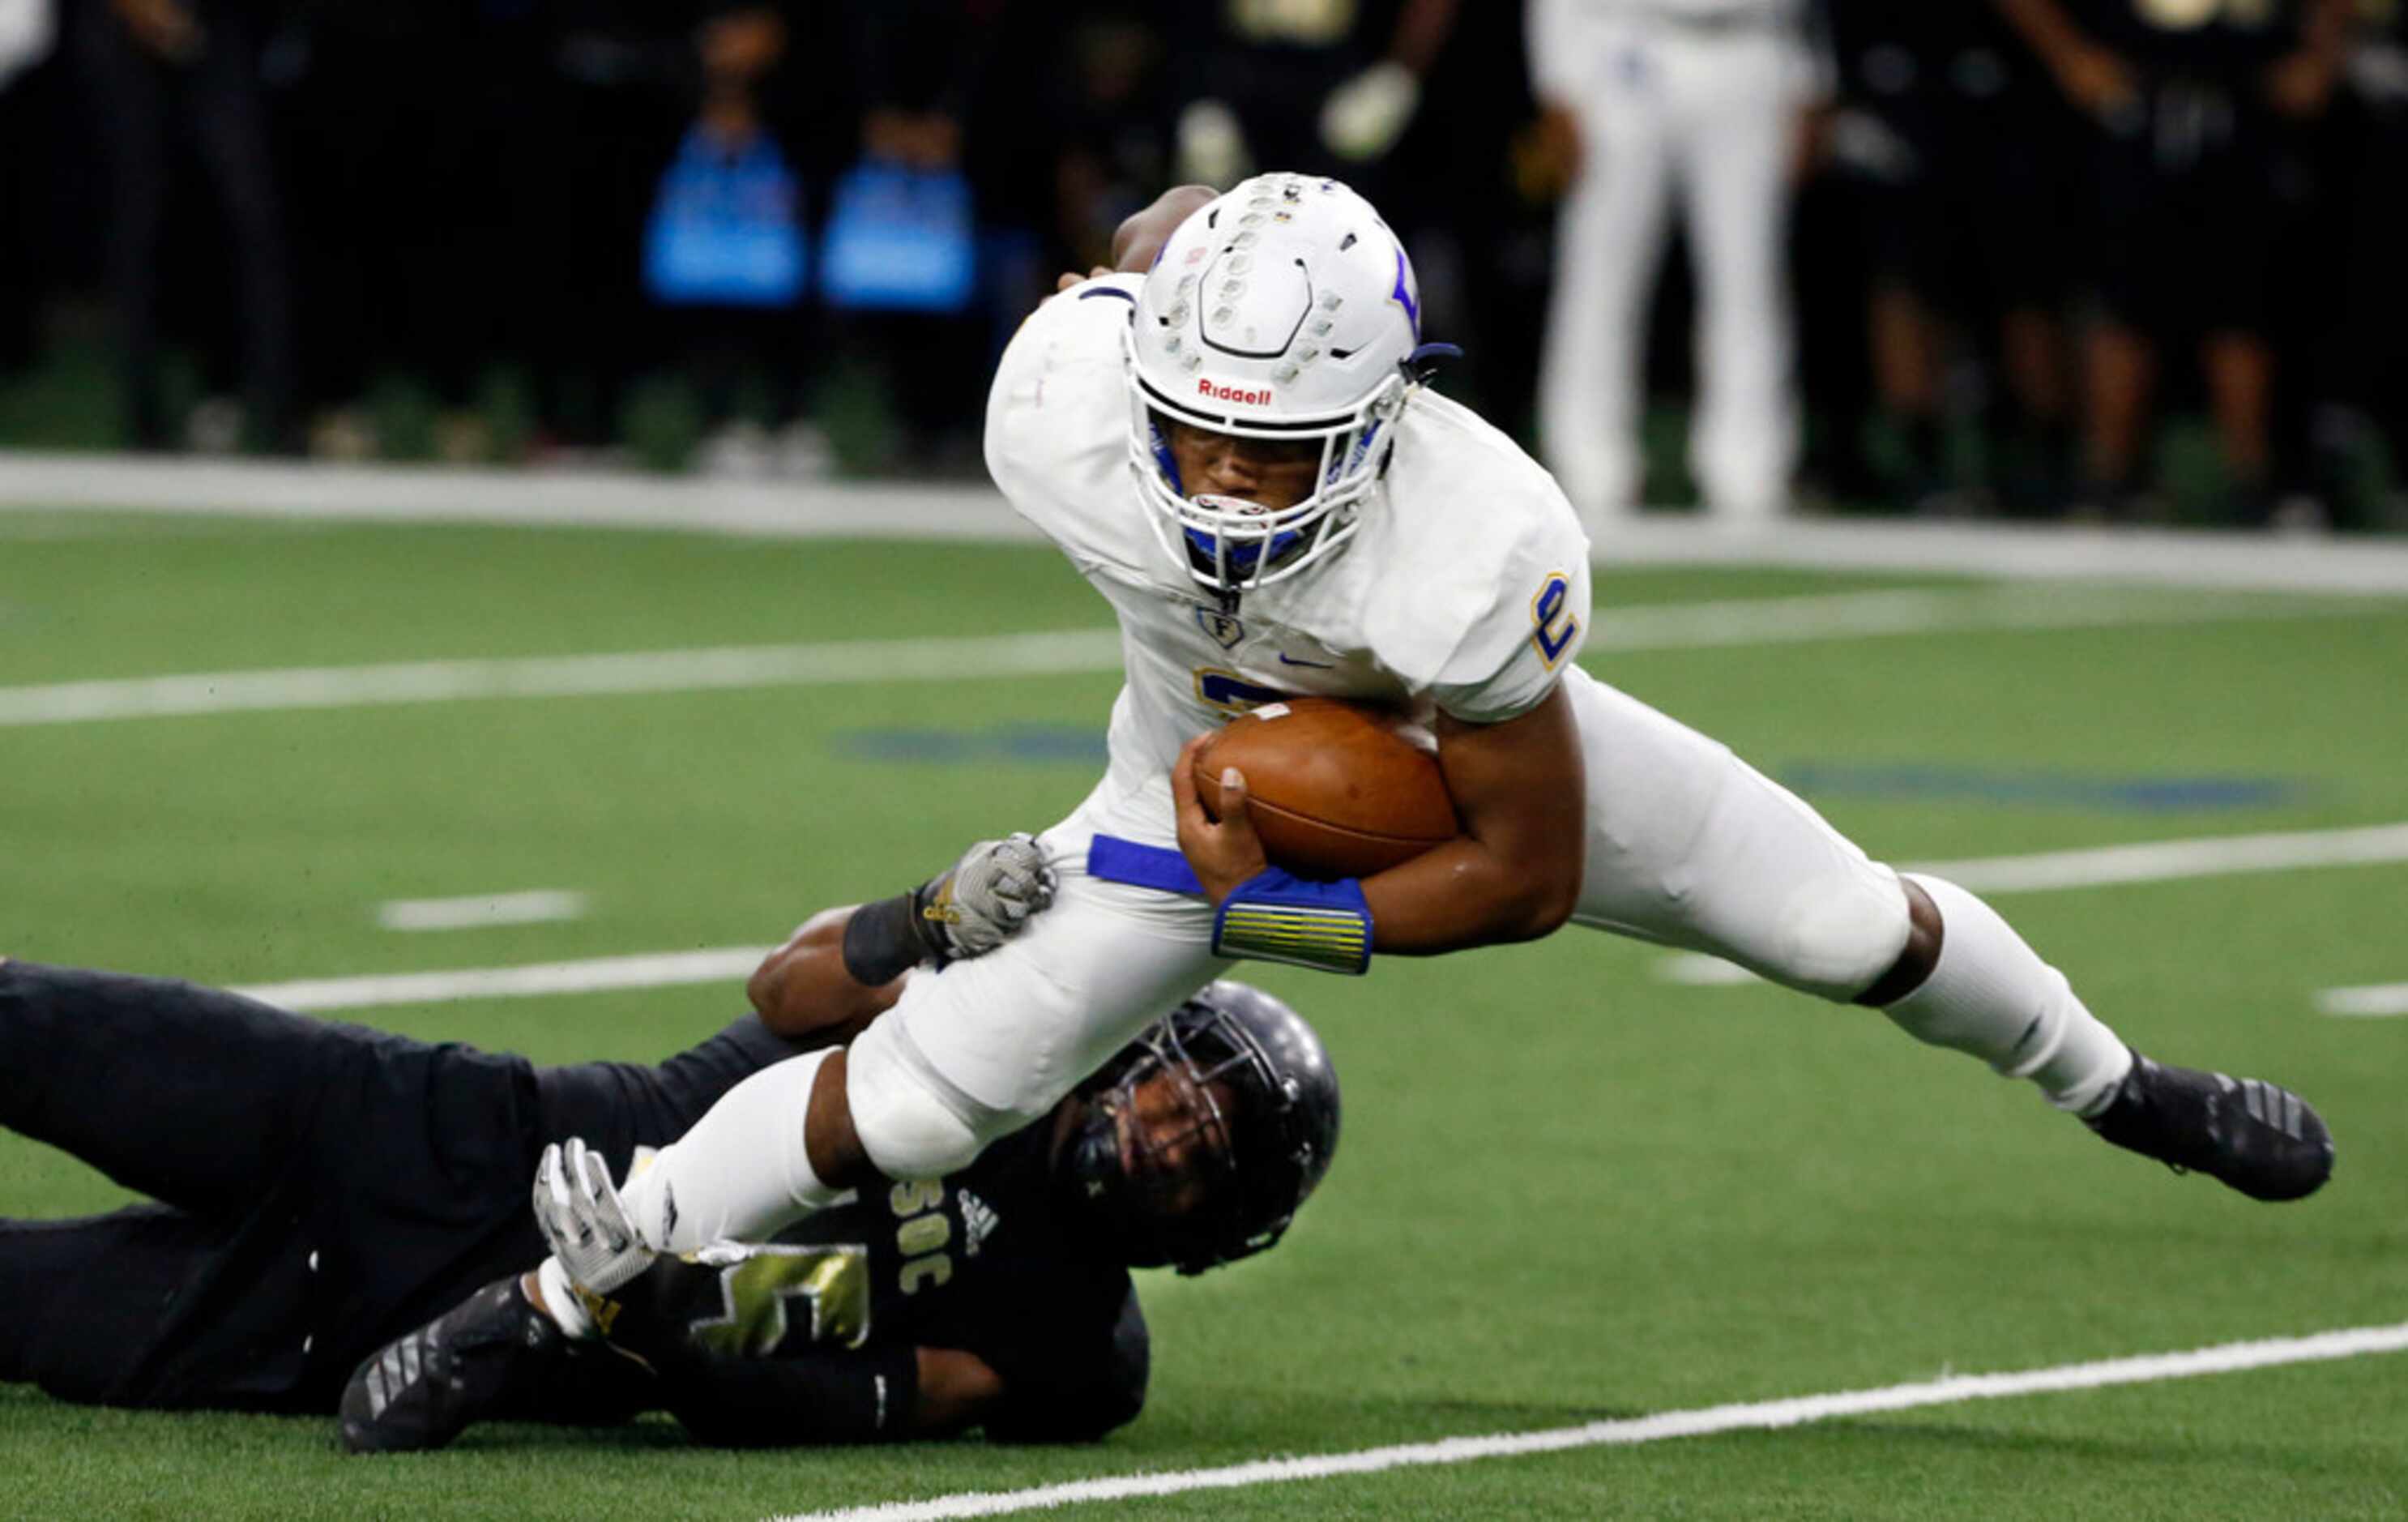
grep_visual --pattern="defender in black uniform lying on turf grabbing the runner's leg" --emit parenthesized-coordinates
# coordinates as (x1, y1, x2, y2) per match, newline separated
(0, 843, 1336, 1450)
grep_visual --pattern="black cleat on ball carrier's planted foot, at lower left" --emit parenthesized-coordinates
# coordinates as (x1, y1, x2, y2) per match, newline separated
(339, 1274, 568, 1452)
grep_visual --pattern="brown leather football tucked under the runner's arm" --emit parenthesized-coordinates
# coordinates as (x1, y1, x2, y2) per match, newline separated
(1194, 699, 1457, 879)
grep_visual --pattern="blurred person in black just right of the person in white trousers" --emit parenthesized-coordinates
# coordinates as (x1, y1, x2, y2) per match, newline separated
(1828, 0, 2081, 511)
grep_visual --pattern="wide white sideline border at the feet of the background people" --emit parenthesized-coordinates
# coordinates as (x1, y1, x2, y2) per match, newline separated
(14, 451, 2408, 597)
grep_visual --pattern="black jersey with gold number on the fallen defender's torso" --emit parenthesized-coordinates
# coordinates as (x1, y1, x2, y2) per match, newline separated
(612, 1122, 1146, 1443)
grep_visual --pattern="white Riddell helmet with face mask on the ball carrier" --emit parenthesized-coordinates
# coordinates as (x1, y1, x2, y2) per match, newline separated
(1127, 173, 1423, 592)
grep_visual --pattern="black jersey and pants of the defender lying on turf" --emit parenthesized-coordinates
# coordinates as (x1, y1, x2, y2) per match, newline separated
(0, 961, 1146, 1443)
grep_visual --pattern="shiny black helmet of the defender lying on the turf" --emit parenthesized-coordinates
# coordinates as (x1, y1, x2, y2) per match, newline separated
(1062, 982, 1338, 1274)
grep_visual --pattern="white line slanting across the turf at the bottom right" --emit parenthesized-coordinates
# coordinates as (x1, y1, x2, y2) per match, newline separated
(775, 1322, 2408, 1522)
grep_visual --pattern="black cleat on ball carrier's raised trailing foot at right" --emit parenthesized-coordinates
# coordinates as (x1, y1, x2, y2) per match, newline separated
(2088, 1053, 2333, 1199)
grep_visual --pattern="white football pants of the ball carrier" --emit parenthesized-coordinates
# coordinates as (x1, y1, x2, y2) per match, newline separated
(847, 667, 1907, 1178)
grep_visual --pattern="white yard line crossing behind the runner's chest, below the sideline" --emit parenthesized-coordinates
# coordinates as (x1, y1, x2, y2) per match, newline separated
(0, 588, 2365, 727)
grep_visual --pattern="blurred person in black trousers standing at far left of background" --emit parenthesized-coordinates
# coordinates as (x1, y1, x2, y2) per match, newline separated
(72, 0, 297, 451)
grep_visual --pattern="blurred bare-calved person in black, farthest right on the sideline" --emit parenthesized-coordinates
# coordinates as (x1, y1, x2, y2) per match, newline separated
(1996, 0, 2350, 523)
